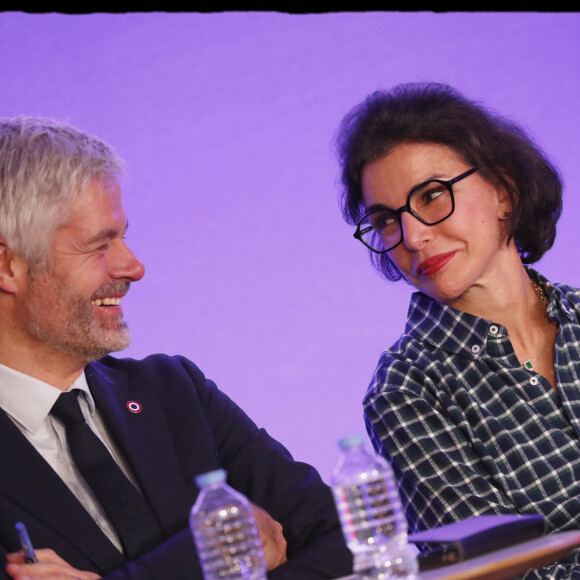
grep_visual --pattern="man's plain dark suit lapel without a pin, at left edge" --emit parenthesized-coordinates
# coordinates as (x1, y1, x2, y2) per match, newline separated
(0, 409, 123, 570)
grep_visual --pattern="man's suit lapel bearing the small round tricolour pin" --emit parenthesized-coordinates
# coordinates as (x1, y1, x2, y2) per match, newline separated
(85, 363, 191, 537)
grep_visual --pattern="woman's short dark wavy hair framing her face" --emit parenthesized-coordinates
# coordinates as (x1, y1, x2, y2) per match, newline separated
(335, 83, 562, 280)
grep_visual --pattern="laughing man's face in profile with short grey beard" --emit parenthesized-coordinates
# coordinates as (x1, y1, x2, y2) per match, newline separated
(18, 178, 145, 364)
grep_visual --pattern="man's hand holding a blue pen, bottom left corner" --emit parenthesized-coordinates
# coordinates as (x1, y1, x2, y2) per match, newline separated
(6, 549, 100, 580)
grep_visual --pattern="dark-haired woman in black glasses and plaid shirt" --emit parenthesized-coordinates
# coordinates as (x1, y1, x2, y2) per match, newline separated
(336, 83, 580, 578)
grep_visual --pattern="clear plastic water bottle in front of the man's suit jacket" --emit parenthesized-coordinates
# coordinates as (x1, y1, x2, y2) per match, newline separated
(189, 469, 266, 580)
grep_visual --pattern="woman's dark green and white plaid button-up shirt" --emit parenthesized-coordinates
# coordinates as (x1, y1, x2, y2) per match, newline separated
(363, 268, 580, 579)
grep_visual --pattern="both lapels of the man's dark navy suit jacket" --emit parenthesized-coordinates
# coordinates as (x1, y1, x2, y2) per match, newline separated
(0, 362, 191, 571)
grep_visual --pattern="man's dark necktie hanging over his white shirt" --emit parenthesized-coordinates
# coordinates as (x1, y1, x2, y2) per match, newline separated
(51, 389, 163, 560)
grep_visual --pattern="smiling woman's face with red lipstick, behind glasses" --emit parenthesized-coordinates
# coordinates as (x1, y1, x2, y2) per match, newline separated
(362, 143, 519, 306)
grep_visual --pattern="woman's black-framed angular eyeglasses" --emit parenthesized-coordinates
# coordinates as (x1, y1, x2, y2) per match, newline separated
(353, 167, 478, 254)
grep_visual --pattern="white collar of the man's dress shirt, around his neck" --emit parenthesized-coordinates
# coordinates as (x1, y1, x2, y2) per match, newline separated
(0, 364, 95, 433)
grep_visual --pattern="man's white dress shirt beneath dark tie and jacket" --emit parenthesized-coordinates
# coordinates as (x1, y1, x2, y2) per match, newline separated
(0, 364, 138, 552)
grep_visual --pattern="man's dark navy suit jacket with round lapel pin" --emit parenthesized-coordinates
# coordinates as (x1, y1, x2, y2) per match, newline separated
(0, 355, 352, 580)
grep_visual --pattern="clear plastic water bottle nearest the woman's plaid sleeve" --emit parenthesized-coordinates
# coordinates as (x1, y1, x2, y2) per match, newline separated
(332, 435, 418, 580)
